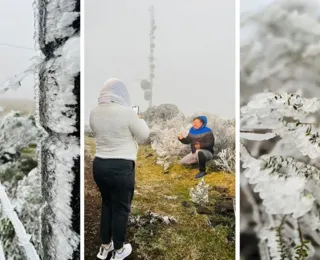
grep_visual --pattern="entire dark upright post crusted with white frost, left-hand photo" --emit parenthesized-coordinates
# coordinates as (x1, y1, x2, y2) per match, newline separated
(34, 0, 80, 260)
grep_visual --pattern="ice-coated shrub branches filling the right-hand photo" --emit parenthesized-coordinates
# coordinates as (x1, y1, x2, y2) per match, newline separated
(240, 1, 320, 260)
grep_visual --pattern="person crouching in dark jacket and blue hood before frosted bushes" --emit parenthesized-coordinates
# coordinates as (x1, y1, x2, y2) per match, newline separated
(178, 116, 214, 179)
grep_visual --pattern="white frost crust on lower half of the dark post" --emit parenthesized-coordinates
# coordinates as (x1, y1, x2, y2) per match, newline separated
(42, 137, 80, 259)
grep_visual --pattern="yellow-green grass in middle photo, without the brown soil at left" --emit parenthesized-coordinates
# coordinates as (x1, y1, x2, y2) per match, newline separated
(86, 137, 235, 260)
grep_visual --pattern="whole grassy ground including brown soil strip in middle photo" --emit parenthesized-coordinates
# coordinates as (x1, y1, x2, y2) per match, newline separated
(85, 137, 235, 260)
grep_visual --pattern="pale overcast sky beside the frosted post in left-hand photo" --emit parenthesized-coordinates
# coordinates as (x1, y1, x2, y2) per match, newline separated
(0, 0, 36, 99)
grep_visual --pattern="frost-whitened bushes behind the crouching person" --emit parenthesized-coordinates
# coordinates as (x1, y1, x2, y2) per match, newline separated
(143, 104, 235, 173)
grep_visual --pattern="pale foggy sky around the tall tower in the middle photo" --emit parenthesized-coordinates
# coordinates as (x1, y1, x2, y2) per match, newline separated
(84, 0, 235, 121)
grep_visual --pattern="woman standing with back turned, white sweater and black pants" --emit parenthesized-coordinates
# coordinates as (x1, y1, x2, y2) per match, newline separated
(90, 79, 149, 260)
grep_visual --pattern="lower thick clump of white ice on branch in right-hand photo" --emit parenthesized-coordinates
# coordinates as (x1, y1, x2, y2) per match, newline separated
(241, 145, 320, 218)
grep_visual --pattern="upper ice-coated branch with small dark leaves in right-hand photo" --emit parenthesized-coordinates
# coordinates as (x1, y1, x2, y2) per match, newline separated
(241, 93, 320, 159)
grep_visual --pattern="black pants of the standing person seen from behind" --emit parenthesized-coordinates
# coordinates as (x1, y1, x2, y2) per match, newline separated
(93, 157, 135, 250)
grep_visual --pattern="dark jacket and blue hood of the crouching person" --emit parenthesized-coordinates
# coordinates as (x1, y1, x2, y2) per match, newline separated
(179, 116, 215, 154)
